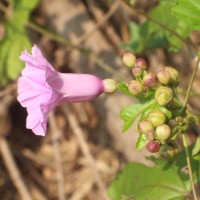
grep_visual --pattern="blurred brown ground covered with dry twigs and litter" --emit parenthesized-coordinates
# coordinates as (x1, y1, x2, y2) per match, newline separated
(0, 0, 200, 200)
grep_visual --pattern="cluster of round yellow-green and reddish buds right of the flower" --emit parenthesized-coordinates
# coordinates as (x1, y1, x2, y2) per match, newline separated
(123, 52, 179, 157)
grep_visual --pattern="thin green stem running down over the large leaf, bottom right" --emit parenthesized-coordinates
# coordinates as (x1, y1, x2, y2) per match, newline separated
(182, 133, 197, 200)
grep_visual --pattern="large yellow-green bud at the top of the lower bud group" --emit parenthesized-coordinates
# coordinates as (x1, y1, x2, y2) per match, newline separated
(147, 110, 166, 127)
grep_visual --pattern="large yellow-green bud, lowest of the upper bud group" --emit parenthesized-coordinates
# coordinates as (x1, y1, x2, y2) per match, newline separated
(155, 86, 173, 106)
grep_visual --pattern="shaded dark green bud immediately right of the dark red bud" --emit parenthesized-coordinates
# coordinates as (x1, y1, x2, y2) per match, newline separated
(159, 141, 179, 158)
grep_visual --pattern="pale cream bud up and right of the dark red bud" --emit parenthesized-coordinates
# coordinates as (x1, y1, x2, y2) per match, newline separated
(156, 124, 171, 143)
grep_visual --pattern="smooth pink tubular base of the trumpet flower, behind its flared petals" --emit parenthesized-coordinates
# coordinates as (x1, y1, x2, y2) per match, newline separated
(46, 73, 104, 103)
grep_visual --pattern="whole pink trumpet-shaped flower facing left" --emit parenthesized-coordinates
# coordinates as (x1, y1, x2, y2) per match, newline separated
(17, 46, 116, 136)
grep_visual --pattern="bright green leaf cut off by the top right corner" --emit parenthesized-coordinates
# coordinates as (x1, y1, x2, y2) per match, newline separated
(171, 0, 200, 30)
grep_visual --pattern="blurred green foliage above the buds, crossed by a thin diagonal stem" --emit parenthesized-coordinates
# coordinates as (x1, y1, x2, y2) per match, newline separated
(122, 0, 191, 54)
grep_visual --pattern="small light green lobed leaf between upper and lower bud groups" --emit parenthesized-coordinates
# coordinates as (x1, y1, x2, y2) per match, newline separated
(120, 99, 155, 132)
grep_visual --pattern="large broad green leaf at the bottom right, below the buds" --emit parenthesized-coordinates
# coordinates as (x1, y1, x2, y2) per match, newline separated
(108, 148, 200, 200)
